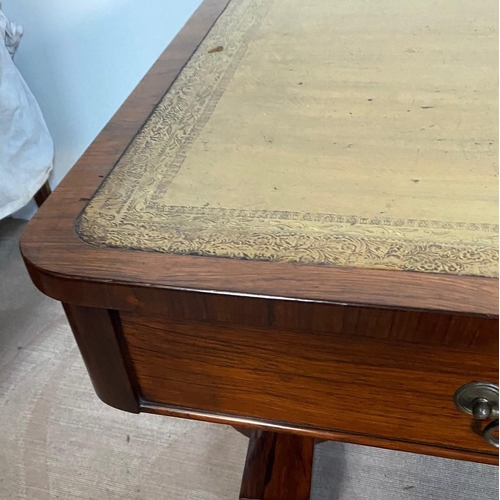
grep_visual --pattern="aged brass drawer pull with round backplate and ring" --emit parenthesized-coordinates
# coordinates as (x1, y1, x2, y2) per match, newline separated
(453, 382, 498, 448)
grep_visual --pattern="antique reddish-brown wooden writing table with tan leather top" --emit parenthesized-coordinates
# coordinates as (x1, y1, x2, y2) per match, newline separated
(21, 0, 498, 500)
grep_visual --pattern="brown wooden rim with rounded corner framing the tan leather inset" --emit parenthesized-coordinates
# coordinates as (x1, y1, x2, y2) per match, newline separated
(17, 0, 498, 316)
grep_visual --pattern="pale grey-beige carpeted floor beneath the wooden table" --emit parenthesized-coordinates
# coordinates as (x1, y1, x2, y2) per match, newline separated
(0, 219, 498, 500)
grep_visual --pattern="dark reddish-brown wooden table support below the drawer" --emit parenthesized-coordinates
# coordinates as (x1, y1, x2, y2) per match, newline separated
(240, 430, 315, 500)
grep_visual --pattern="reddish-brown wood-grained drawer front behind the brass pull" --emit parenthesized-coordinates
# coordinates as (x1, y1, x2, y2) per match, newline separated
(121, 314, 498, 455)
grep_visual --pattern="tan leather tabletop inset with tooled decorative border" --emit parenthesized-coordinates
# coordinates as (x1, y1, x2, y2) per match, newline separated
(78, 0, 498, 276)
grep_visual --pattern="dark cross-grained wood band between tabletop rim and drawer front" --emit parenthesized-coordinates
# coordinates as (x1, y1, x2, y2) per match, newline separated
(34, 282, 498, 353)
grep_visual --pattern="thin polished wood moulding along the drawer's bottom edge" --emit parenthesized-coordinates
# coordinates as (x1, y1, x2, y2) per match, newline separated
(139, 398, 499, 465)
